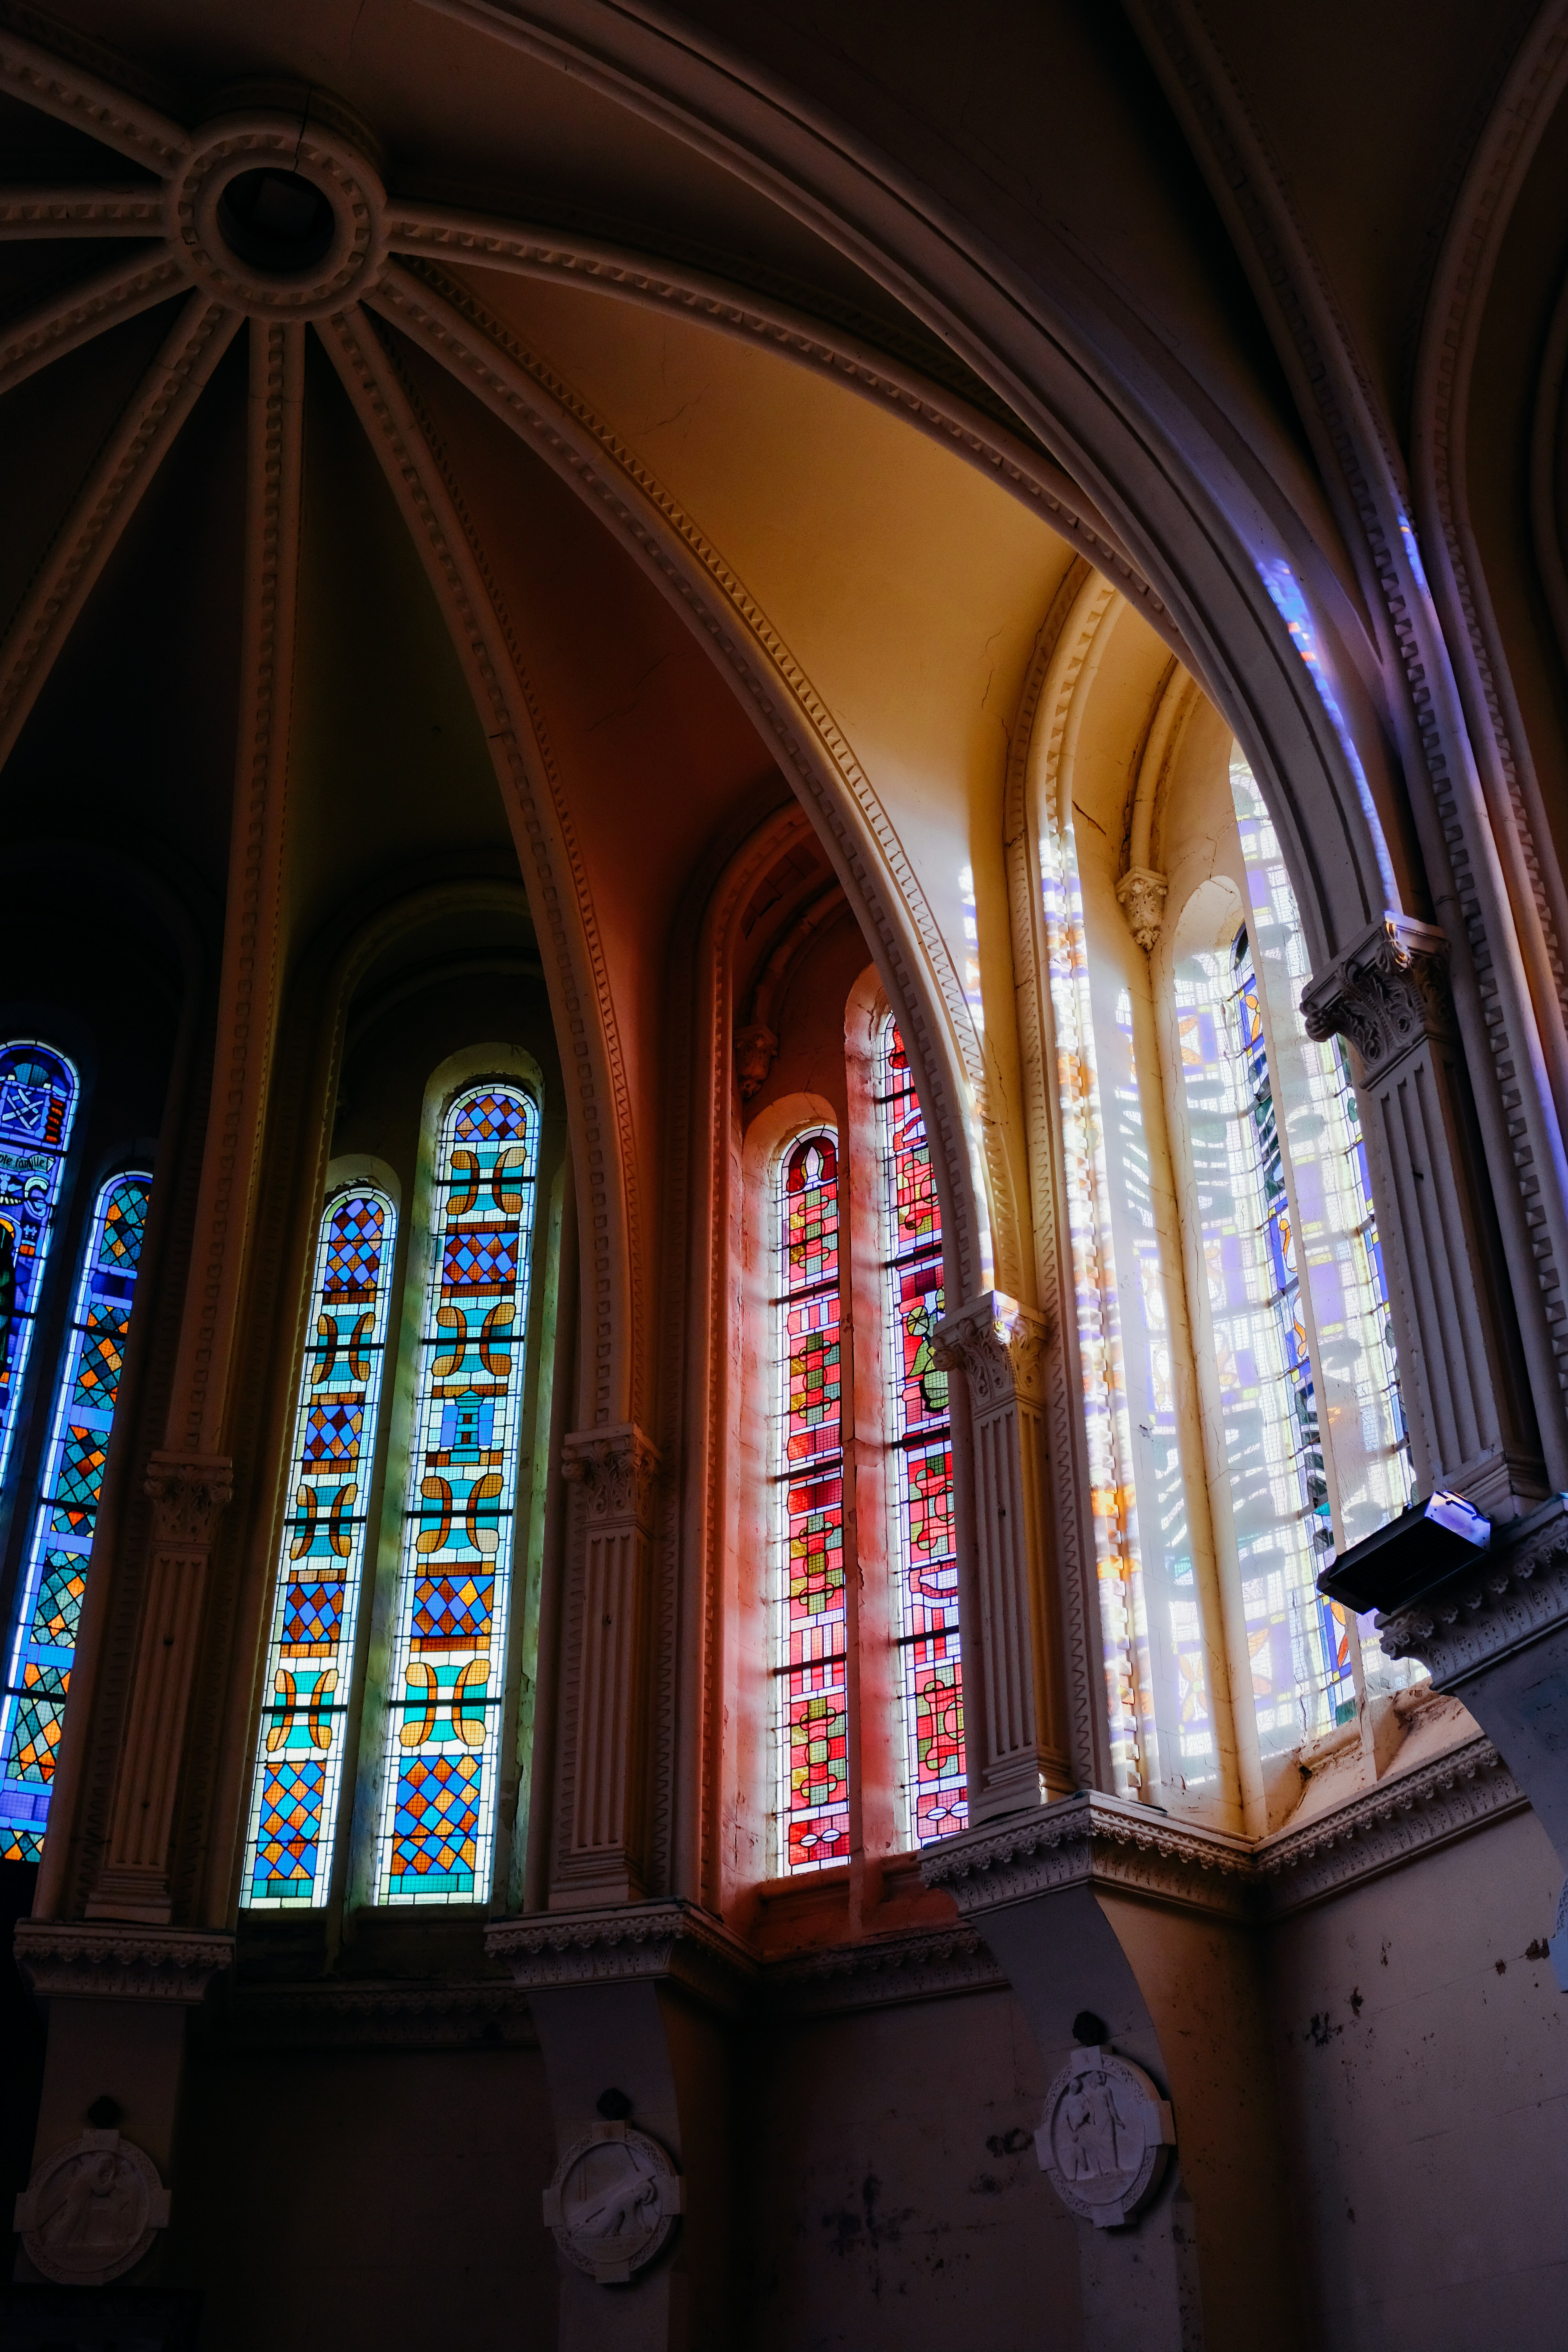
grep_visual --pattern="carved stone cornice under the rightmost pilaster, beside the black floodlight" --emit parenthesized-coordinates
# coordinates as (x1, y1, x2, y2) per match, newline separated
(1377, 1496, 1568, 1691)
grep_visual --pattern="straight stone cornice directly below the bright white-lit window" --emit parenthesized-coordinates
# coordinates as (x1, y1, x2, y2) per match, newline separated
(1253, 1738, 1528, 1917)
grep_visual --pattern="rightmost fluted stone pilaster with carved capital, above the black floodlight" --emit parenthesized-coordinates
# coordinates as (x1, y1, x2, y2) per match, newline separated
(1302, 915, 1544, 1519)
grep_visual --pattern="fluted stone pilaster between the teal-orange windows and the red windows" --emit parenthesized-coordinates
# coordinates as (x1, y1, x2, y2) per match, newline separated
(550, 1421, 658, 1910)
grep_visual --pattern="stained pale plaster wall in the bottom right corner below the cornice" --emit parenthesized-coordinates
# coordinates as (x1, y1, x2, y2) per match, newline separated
(1272, 1813, 1568, 2352)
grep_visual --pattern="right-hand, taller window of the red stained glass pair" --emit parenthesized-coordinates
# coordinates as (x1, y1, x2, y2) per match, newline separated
(877, 1021, 969, 1846)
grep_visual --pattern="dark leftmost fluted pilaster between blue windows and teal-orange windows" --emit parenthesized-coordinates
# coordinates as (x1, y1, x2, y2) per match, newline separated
(87, 1454, 233, 1924)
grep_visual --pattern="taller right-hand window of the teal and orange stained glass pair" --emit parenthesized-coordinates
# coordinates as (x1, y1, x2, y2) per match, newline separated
(376, 1082, 538, 1903)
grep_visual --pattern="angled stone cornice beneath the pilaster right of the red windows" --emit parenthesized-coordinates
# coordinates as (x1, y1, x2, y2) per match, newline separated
(922, 1792, 1253, 1917)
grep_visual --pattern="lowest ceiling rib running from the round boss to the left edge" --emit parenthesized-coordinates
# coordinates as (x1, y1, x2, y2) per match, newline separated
(0, 294, 240, 762)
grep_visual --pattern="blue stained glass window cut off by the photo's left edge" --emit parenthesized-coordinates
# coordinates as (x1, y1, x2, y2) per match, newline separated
(0, 1042, 78, 1484)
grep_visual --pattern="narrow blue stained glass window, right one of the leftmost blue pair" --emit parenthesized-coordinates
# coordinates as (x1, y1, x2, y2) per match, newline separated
(0, 1171, 153, 1863)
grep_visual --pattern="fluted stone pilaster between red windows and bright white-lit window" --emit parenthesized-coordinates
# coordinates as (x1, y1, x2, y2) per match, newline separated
(933, 1291, 1072, 1820)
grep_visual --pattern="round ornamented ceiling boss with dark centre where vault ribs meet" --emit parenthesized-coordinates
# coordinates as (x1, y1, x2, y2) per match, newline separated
(165, 108, 386, 318)
